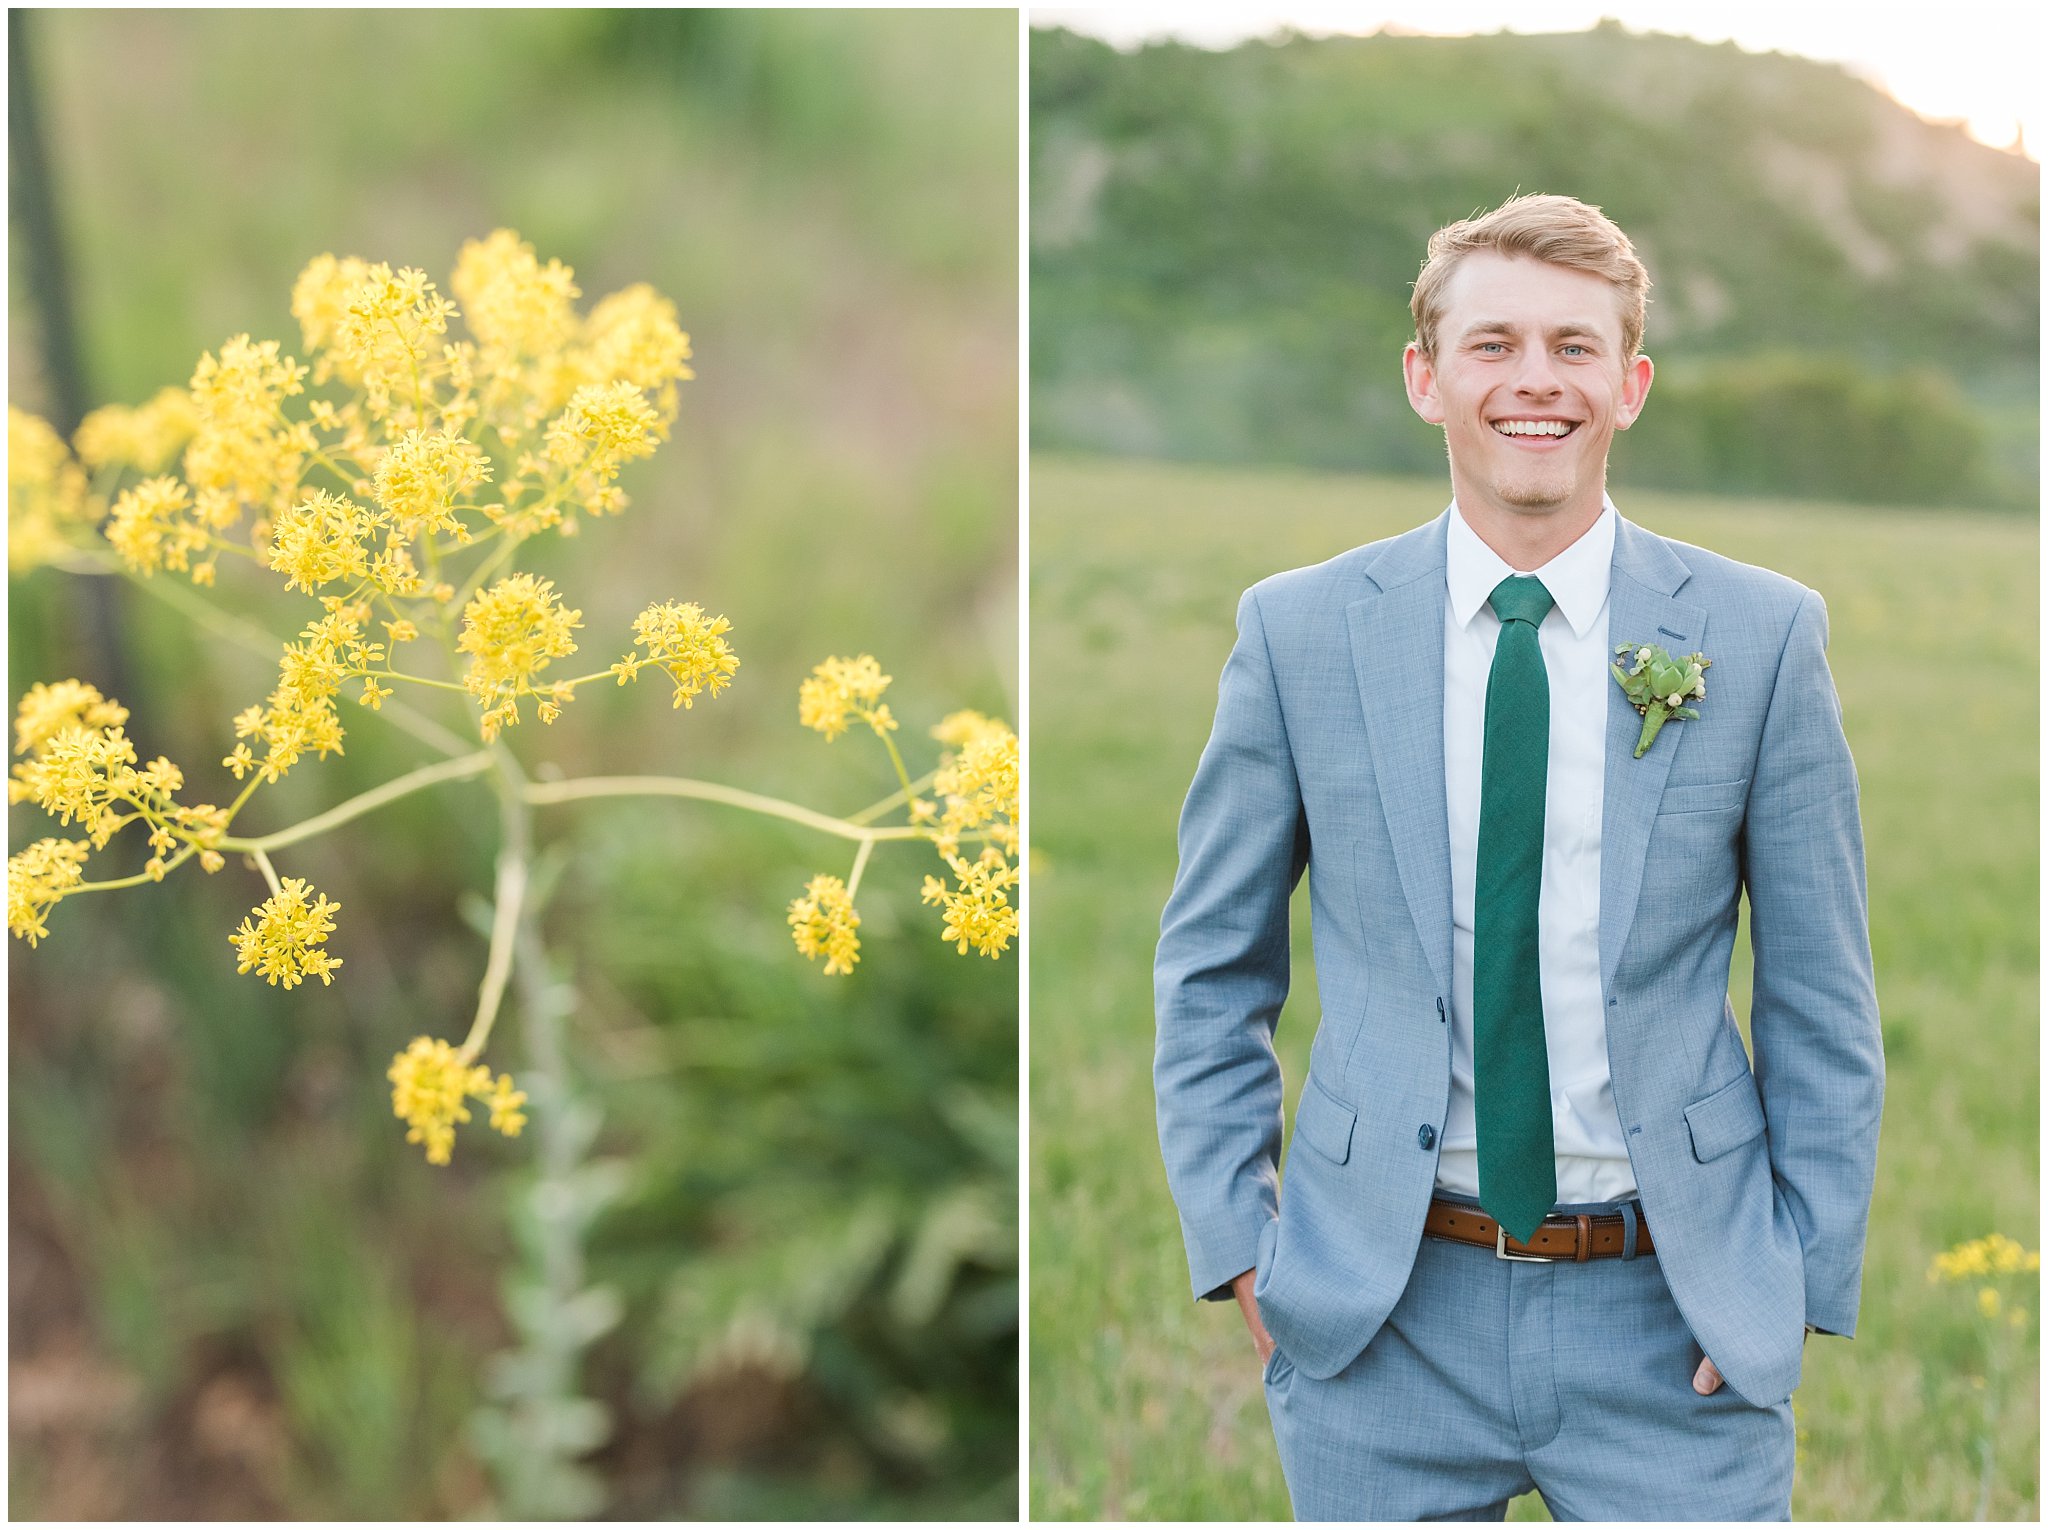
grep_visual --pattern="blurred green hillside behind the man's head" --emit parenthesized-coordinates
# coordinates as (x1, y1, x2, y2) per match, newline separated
(1030, 23, 2040, 506)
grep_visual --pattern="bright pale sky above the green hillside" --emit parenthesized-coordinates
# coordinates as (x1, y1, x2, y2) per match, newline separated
(1030, 0, 2042, 160)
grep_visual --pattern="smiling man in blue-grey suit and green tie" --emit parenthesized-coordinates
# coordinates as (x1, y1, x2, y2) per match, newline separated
(1155, 197, 1884, 1520)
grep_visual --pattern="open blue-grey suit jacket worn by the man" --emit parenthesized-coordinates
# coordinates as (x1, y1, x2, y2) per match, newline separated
(1155, 512, 1884, 1405)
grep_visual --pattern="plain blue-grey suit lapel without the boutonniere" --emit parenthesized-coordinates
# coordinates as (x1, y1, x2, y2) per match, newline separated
(1346, 516, 1450, 995)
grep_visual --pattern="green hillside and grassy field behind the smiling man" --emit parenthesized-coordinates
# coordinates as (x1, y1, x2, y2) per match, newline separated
(1030, 17, 2040, 1520)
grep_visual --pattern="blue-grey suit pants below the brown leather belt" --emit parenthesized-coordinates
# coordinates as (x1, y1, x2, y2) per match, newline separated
(1266, 1196, 1792, 1520)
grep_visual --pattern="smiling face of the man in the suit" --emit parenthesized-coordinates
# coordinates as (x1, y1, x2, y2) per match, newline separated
(1403, 250, 1651, 555)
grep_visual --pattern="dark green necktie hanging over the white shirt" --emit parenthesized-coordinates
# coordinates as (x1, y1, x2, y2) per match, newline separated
(1473, 578, 1556, 1243)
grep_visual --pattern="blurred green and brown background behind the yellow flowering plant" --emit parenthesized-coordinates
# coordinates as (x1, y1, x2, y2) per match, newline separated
(8, 10, 1018, 1518)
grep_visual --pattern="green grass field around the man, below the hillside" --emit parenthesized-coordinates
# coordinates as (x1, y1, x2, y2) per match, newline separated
(1030, 457, 2040, 1520)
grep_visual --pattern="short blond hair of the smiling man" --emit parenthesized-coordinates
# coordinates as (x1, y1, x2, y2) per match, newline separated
(1409, 197, 1651, 360)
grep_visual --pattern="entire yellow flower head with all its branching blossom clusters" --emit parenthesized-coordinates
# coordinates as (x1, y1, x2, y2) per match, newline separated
(8, 229, 1020, 1163)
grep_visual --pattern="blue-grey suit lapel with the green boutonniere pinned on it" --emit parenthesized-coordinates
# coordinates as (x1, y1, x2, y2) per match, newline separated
(1599, 520, 1706, 987)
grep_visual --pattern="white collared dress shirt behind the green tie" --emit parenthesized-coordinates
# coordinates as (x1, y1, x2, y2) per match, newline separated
(1436, 500, 1636, 1204)
